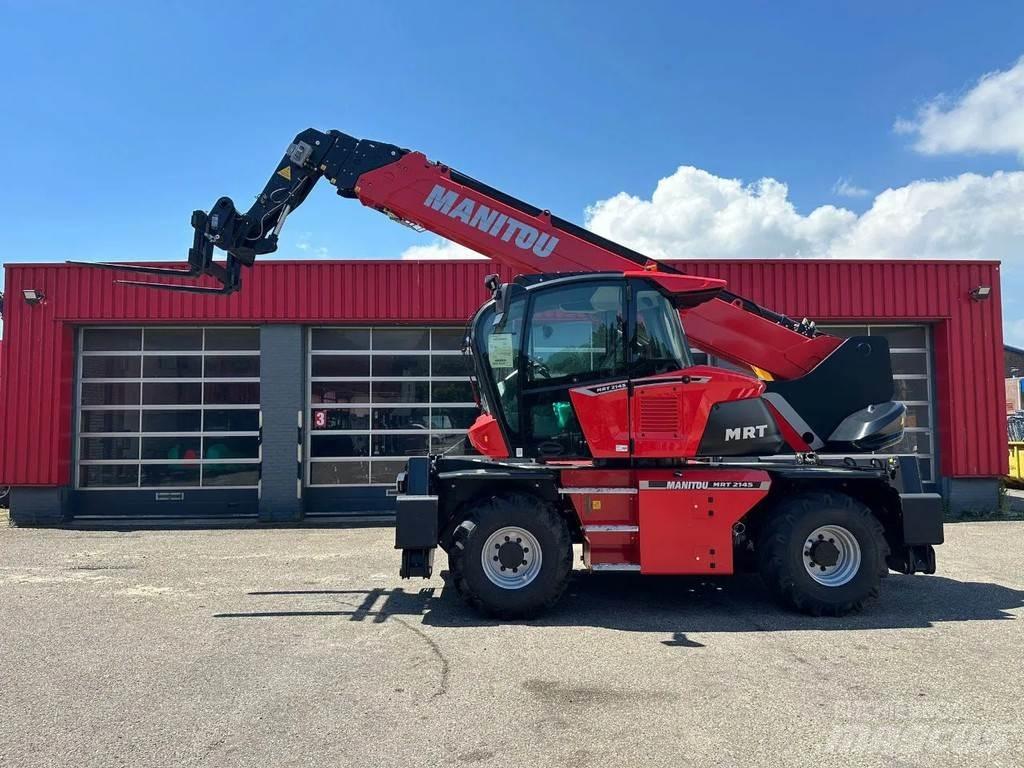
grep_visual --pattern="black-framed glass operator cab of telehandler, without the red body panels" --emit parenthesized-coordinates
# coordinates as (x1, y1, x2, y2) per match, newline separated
(470, 273, 702, 459)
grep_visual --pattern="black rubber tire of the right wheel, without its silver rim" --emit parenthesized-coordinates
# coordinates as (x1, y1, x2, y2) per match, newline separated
(757, 492, 889, 616)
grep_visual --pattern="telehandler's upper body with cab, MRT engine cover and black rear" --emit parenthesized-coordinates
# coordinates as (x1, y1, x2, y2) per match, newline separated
(469, 271, 904, 461)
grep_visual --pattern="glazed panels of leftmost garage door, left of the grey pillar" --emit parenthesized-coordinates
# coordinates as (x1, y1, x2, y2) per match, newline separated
(75, 328, 260, 490)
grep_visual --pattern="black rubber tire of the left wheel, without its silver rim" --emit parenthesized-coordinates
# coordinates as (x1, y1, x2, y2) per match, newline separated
(449, 494, 572, 618)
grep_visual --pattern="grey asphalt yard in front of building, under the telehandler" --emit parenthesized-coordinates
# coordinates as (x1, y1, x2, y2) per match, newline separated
(0, 522, 1024, 768)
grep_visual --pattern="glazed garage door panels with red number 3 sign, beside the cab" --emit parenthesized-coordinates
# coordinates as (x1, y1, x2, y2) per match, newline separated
(304, 327, 478, 511)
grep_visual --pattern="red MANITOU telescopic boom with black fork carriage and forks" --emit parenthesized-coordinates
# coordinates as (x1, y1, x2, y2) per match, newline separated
(81, 129, 840, 379)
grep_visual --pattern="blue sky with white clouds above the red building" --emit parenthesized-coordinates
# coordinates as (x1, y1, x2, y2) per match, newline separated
(0, 0, 1024, 344)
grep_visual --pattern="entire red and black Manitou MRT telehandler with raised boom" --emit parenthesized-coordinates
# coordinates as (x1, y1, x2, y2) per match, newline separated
(86, 130, 943, 617)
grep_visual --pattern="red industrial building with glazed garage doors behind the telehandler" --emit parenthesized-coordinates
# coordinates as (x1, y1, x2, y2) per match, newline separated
(0, 260, 1007, 524)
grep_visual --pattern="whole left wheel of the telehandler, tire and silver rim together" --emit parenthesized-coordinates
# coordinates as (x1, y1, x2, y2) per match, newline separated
(449, 494, 572, 618)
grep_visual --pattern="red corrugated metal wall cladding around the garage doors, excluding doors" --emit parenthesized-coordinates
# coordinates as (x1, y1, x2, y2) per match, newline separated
(0, 260, 1007, 485)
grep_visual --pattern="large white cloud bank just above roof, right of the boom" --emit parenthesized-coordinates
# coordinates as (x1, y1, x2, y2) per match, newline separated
(586, 166, 1024, 262)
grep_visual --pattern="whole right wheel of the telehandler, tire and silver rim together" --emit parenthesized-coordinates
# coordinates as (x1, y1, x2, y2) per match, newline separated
(757, 493, 889, 615)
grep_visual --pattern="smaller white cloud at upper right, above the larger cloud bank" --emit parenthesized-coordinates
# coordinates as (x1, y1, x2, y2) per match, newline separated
(894, 57, 1024, 162)
